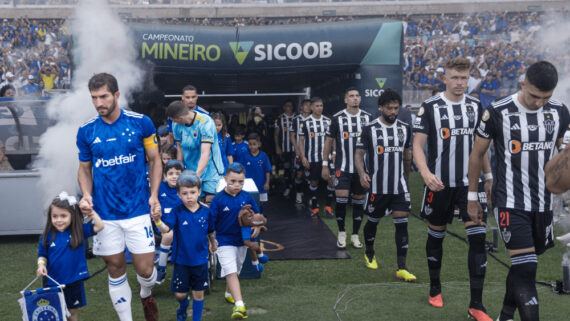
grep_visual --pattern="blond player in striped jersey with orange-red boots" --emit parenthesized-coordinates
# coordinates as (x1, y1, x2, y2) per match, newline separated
(413, 57, 492, 320)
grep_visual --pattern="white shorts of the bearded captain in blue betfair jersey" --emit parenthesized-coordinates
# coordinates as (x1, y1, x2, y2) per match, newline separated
(93, 214, 154, 256)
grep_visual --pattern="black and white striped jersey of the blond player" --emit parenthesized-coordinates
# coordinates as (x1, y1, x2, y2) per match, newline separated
(414, 93, 482, 187)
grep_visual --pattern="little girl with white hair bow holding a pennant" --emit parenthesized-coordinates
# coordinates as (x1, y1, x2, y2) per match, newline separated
(36, 192, 104, 321)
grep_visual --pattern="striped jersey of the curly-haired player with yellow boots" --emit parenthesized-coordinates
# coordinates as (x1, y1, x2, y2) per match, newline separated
(356, 118, 412, 194)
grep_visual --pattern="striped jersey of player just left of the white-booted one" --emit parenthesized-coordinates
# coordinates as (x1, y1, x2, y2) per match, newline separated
(297, 115, 331, 163)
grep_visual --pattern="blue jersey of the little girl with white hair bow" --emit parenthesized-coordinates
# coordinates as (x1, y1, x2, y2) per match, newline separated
(38, 223, 96, 286)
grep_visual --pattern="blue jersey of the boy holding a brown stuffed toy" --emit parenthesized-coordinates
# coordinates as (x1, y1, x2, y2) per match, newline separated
(210, 190, 259, 246)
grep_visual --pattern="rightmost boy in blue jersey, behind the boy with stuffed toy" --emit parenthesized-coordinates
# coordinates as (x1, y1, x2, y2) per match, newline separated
(242, 133, 271, 213)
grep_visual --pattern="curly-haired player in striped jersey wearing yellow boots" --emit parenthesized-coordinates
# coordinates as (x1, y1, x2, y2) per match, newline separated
(355, 88, 416, 281)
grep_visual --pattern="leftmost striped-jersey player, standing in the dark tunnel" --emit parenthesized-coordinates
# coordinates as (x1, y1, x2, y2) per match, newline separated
(273, 100, 295, 197)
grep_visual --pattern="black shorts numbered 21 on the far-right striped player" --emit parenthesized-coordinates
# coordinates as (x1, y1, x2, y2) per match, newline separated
(495, 208, 554, 254)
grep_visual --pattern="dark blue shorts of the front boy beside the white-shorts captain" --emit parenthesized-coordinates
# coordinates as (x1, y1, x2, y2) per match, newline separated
(170, 263, 210, 293)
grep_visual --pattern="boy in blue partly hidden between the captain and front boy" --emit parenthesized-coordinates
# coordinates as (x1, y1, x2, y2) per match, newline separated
(156, 160, 184, 284)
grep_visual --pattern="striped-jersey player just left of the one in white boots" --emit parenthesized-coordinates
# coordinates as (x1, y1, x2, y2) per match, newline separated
(298, 97, 334, 217)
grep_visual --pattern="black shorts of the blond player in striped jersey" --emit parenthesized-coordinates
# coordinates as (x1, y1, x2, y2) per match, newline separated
(421, 183, 487, 226)
